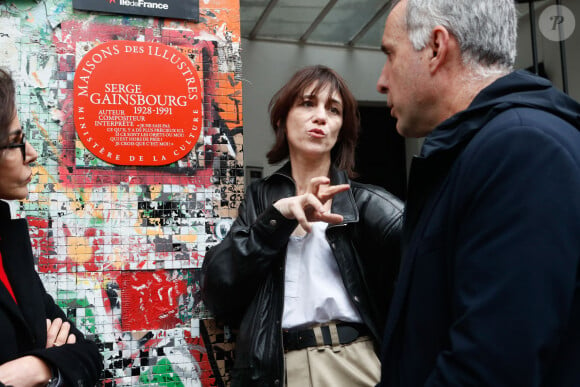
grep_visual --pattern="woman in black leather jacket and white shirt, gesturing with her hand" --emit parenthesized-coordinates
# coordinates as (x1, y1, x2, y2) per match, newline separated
(202, 66, 402, 387)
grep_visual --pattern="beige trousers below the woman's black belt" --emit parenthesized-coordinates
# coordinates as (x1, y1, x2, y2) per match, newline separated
(285, 330, 381, 387)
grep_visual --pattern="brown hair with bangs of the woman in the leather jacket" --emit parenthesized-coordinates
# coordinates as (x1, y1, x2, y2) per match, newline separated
(266, 65, 360, 177)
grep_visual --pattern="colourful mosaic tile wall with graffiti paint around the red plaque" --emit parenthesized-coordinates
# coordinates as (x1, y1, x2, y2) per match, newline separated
(0, 0, 244, 386)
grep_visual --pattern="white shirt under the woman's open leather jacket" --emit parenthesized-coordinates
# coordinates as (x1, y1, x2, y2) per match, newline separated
(282, 222, 362, 329)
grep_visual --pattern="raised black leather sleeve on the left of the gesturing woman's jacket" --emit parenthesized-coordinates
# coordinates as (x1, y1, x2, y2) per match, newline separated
(202, 185, 297, 325)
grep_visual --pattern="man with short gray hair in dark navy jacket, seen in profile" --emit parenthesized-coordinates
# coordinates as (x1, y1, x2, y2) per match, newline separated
(377, 0, 580, 387)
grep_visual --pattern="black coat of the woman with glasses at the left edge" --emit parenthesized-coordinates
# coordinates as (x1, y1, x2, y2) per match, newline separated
(0, 203, 103, 387)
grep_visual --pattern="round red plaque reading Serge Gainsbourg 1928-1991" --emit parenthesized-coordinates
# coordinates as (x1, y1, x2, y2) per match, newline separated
(74, 40, 202, 165)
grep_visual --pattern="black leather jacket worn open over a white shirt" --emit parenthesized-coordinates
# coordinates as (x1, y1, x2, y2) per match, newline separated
(202, 163, 403, 387)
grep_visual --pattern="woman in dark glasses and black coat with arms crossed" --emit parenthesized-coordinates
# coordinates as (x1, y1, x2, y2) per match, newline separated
(0, 69, 103, 386)
